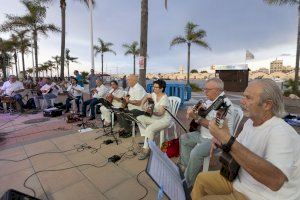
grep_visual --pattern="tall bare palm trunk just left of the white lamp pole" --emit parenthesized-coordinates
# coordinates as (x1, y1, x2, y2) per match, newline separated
(60, 0, 65, 80)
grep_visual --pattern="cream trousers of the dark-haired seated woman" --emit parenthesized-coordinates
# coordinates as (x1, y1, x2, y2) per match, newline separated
(137, 115, 170, 149)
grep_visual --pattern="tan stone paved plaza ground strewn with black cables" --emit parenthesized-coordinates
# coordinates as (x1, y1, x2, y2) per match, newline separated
(0, 93, 300, 200)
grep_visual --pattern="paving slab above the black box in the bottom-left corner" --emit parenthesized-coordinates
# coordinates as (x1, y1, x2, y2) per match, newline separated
(0, 168, 43, 196)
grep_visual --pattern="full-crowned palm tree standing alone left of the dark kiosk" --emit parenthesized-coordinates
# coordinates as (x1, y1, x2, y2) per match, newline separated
(170, 22, 210, 85)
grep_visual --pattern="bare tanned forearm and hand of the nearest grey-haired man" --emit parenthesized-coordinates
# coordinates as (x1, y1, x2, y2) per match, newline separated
(209, 120, 288, 191)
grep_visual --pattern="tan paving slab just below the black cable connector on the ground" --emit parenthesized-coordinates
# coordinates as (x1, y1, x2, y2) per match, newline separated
(82, 163, 130, 192)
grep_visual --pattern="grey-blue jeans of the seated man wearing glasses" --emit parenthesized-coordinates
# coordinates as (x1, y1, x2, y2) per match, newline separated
(180, 131, 211, 187)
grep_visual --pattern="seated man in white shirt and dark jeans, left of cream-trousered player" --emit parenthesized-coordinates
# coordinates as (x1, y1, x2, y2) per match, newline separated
(81, 79, 108, 120)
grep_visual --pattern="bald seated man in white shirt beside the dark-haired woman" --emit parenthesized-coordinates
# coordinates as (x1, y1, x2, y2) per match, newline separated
(119, 74, 147, 138)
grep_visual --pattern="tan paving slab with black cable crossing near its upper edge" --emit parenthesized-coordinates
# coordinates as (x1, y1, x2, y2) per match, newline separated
(37, 162, 85, 194)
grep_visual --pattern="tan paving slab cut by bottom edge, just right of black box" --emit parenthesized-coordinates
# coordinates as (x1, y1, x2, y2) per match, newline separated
(49, 180, 107, 200)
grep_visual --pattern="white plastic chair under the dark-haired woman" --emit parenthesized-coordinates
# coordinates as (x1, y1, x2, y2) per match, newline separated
(160, 96, 181, 147)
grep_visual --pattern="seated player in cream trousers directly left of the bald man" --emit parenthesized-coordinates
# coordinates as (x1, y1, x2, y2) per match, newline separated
(100, 80, 124, 126)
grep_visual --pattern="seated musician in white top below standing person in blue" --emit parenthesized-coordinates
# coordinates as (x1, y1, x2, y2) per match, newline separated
(66, 77, 84, 113)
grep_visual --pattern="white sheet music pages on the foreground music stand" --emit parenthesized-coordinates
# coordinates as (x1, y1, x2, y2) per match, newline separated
(146, 141, 186, 200)
